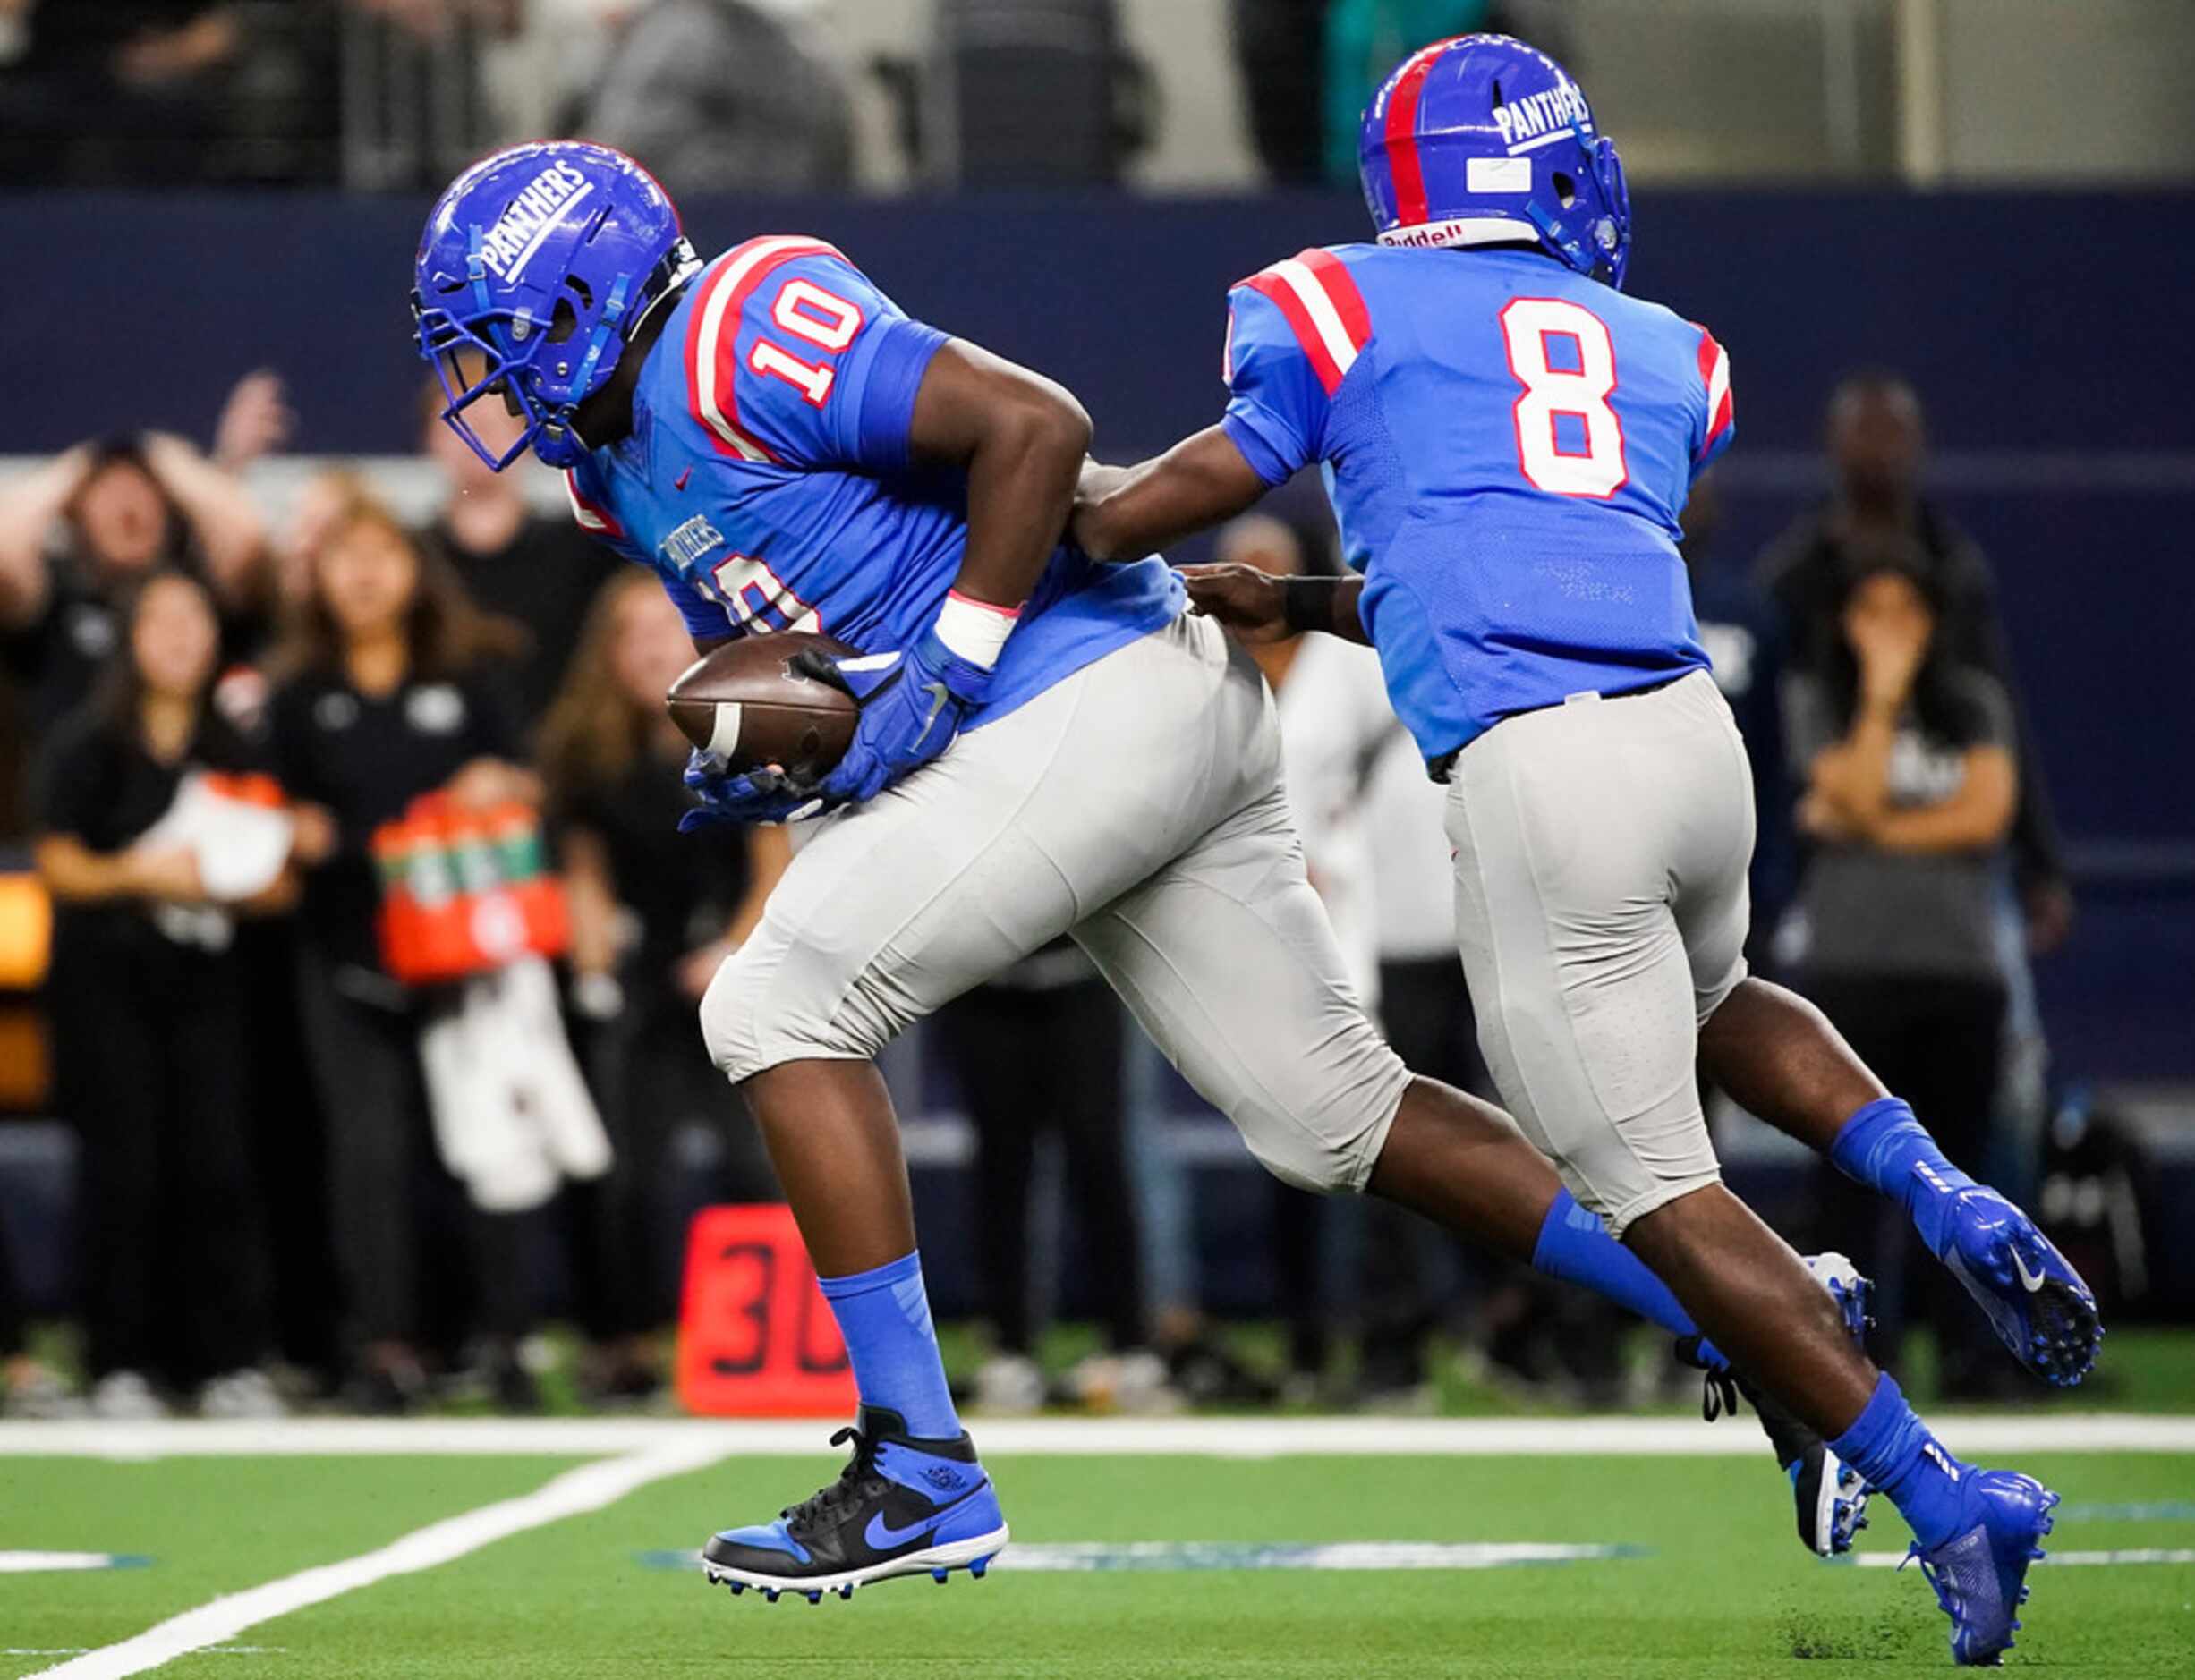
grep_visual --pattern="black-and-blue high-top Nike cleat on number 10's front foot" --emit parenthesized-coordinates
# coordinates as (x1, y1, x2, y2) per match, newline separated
(701, 1406, 1008, 1603)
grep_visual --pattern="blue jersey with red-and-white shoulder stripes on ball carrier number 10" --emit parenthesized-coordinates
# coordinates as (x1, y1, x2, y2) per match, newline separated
(566, 237, 1183, 728)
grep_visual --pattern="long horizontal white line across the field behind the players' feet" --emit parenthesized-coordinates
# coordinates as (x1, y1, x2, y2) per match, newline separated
(0, 1413, 2195, 1458)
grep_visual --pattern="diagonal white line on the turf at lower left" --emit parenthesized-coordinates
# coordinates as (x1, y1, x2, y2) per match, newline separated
(19, 1434, 724, 1680)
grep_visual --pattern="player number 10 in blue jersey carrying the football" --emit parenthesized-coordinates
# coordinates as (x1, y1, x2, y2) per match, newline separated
(413, 142, 1887, 1599)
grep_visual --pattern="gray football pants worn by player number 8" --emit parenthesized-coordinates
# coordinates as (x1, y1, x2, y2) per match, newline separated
(1447, 671, 1754, 1237)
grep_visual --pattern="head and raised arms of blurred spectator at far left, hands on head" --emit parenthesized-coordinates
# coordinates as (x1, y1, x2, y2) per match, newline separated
(0, 392, 279, 739)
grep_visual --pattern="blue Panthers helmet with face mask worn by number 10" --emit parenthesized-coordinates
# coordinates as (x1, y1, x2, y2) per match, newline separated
(413, 140, 701, 471)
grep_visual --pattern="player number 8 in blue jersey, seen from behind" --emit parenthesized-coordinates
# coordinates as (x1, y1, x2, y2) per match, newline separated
(1071, 35, 2101, 1662)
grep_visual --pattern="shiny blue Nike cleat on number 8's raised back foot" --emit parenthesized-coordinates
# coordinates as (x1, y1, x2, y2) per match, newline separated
(1918, 1169, 2103, 1388)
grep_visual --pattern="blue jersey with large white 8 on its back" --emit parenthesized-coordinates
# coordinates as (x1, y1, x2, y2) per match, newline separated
(1222, 246, 1731, 759)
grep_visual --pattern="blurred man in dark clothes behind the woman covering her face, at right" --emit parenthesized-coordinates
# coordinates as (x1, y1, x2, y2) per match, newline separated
(1756, 379, 2072, 952)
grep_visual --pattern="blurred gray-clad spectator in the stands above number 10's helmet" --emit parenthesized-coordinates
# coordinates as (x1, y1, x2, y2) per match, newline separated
(580, 0, 854, 195)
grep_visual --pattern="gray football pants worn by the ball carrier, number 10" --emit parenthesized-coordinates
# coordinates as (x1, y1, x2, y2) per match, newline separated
(701, 616, 1409, 1191)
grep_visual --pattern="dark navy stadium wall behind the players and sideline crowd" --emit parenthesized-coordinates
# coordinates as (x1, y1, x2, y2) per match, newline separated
(0, 191, 2195, 1077)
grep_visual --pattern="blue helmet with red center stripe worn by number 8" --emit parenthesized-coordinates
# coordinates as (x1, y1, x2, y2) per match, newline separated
(1357, 35, 1631, 287)
